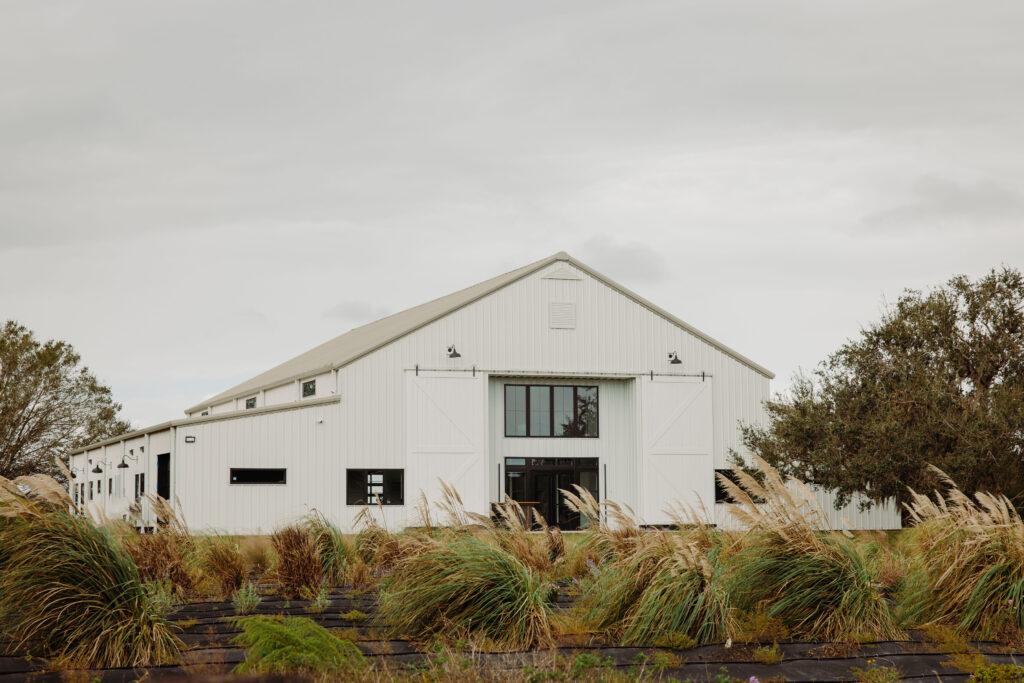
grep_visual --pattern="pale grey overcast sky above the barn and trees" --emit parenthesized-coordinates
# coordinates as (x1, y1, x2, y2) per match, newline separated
(0, 0, 1024, 427)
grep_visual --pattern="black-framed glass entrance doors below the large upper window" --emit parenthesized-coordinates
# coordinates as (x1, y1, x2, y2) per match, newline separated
(505, 458, 600, 530)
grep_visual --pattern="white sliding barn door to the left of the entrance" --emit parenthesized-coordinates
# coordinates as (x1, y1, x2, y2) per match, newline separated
(406, 372, 488, 513)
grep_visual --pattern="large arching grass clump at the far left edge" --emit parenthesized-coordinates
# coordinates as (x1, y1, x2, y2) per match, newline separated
(0, 476, 181, 669)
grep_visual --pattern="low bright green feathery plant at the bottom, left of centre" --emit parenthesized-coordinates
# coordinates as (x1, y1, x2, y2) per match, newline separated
(231, 615, 366, 676)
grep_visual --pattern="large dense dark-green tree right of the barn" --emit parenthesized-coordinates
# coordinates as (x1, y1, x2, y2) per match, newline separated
(742, 267, 1024, 508)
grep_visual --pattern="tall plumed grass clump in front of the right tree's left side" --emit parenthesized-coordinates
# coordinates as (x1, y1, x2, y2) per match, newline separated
(719, 459, 901, 641)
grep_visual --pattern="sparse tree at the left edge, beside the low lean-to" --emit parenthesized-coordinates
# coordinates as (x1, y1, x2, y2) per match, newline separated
(0, 321, 131, 478)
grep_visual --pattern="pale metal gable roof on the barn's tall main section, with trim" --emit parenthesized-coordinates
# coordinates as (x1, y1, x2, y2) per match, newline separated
(185, 252, 775, 414)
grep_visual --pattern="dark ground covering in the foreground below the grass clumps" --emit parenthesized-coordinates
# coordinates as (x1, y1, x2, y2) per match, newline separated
(0, 592, 1024, 683)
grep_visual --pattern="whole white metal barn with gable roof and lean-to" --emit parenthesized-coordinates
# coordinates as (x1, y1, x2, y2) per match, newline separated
(71, 252, 899, 533)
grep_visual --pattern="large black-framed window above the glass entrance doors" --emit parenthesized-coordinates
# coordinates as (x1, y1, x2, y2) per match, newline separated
(505, 384, 598, 437)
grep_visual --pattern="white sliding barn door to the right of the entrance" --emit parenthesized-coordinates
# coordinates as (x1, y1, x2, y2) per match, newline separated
(640, 377, 715, 524)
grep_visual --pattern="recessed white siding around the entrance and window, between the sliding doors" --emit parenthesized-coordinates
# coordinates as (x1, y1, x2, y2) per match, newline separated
(487, 376, 637, 508)
